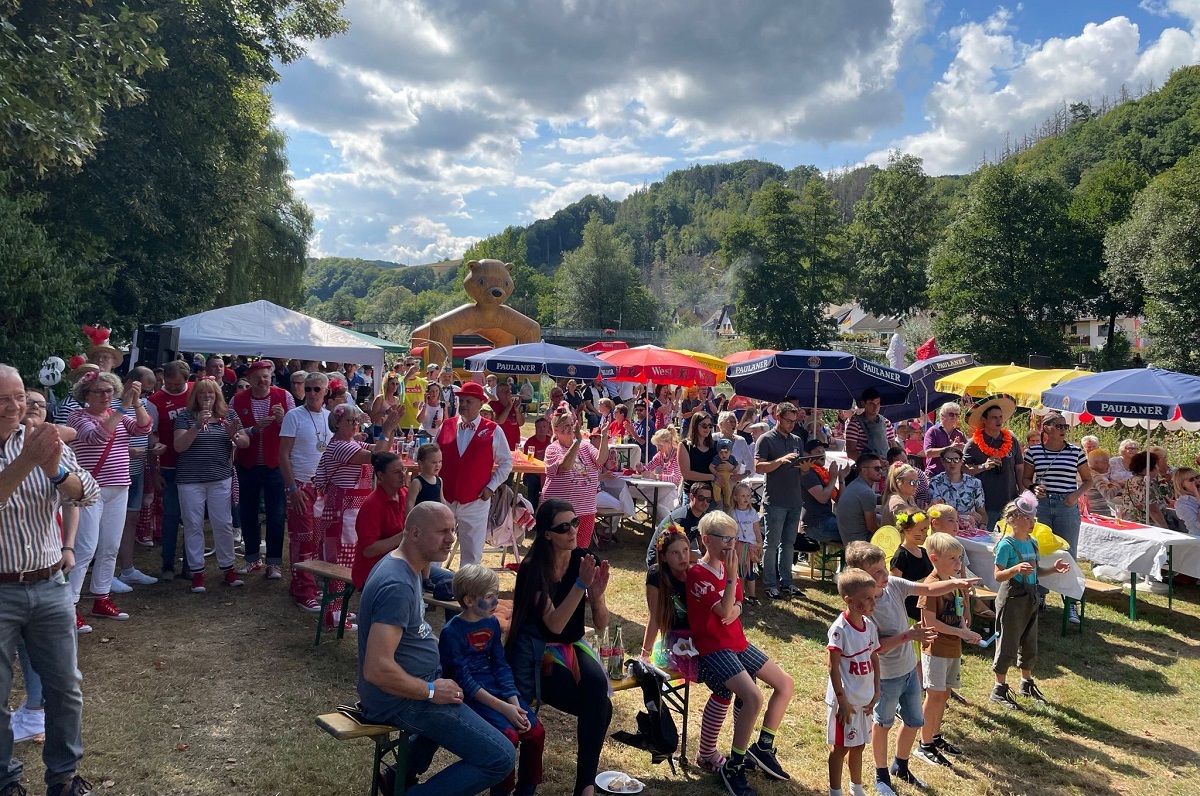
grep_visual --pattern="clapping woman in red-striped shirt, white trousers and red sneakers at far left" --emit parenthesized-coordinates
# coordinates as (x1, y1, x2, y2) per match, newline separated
(67, 372, 150, 626)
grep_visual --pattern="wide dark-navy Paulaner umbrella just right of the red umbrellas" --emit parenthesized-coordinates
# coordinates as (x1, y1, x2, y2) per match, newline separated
(725, 351, 912, 409)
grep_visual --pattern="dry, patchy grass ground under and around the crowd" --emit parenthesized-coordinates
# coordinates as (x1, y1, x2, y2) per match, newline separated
(11, 529, 1200, 796)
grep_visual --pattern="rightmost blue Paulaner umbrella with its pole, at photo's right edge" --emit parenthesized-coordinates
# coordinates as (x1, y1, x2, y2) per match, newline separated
(1042, 367, 1200, 528)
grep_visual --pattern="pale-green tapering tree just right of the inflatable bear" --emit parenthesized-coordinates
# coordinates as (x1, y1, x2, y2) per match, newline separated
(554, 214, 658, 329)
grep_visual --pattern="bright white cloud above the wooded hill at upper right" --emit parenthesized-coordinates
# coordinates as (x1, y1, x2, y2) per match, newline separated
(866, 6, 1200, 174)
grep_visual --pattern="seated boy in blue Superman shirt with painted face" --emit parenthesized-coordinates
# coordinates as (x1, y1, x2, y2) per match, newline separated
(438, 564, 546, 796)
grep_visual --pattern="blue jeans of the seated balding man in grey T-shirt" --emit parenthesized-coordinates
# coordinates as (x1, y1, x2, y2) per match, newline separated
(384, 699, 517, 796)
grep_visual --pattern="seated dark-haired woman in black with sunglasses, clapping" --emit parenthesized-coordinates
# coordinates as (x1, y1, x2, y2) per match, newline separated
(505, 498, 612, 796)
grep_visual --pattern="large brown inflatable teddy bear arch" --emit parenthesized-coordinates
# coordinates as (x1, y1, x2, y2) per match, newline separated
(413, 259, 541, 364)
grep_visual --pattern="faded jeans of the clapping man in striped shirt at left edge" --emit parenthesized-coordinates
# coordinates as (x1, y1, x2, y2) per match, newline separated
(0, 574, 84, 791)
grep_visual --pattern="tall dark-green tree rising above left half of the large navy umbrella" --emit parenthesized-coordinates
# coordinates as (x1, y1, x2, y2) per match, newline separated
(721, 180, 845, 349)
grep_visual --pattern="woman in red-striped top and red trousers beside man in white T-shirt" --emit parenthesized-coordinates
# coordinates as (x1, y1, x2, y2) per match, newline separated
(312, 401, 401, 629)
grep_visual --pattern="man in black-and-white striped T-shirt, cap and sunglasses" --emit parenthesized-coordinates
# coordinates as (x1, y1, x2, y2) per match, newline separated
(1020, 412, 1092, 624)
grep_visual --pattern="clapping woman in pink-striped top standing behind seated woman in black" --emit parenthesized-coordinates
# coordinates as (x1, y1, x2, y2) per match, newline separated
(541, 412, 608, 547)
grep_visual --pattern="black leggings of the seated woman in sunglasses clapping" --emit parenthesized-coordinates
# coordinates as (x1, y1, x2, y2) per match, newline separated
(541, 653, 612, 796)
